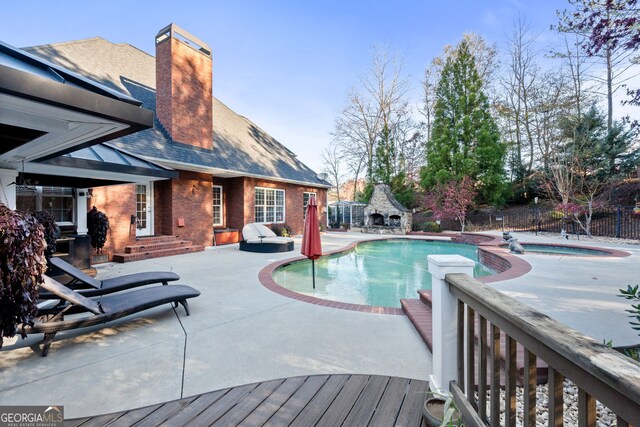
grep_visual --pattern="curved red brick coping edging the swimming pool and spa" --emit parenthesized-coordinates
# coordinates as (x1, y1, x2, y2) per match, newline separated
(258, 233, 631, 315)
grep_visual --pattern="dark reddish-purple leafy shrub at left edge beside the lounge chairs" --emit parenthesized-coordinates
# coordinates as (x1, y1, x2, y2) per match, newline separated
(0, 203, 47, 347)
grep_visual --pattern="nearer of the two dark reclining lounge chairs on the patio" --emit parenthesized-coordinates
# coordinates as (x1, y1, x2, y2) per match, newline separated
(20, 276, 200, 357)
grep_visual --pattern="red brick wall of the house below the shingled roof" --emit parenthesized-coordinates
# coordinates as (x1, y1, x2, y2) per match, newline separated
(88, 171, 327, 254)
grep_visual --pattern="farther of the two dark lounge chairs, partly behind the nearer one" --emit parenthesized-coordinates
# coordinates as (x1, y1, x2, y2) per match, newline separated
(39, 257, 180, 299)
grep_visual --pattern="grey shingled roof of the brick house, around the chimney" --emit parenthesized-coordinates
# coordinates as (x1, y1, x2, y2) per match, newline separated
(24, 37, 330, 187)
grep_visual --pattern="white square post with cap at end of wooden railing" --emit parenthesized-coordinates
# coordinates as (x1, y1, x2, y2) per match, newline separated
(427, 255, 475, 393)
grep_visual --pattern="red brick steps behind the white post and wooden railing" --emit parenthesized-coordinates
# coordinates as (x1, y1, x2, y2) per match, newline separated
(400, 290, 548, 385)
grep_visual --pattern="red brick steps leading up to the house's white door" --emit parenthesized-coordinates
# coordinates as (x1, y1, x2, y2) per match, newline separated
(113, 236, 204, 263)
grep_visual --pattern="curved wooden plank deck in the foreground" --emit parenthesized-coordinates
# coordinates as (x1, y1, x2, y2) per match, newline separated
(65, 375, 429, 427)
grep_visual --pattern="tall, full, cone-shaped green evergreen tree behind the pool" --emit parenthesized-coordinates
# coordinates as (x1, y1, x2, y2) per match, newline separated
(421, 40, 506, 205)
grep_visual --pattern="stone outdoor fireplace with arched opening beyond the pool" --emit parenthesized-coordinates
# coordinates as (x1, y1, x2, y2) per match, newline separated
(362, 184, 413, 234)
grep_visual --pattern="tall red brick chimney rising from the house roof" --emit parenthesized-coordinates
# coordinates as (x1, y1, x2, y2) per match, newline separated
(156, 24, 213, 150)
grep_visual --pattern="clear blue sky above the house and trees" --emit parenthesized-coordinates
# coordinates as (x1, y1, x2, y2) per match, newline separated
(0, 0, 584, 172)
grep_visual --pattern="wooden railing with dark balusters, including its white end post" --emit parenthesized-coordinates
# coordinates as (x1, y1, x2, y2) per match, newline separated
(429, 255, 640, 427)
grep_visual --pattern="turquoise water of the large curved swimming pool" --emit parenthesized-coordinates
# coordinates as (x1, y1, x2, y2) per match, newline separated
(273, 239, 494, 307)
